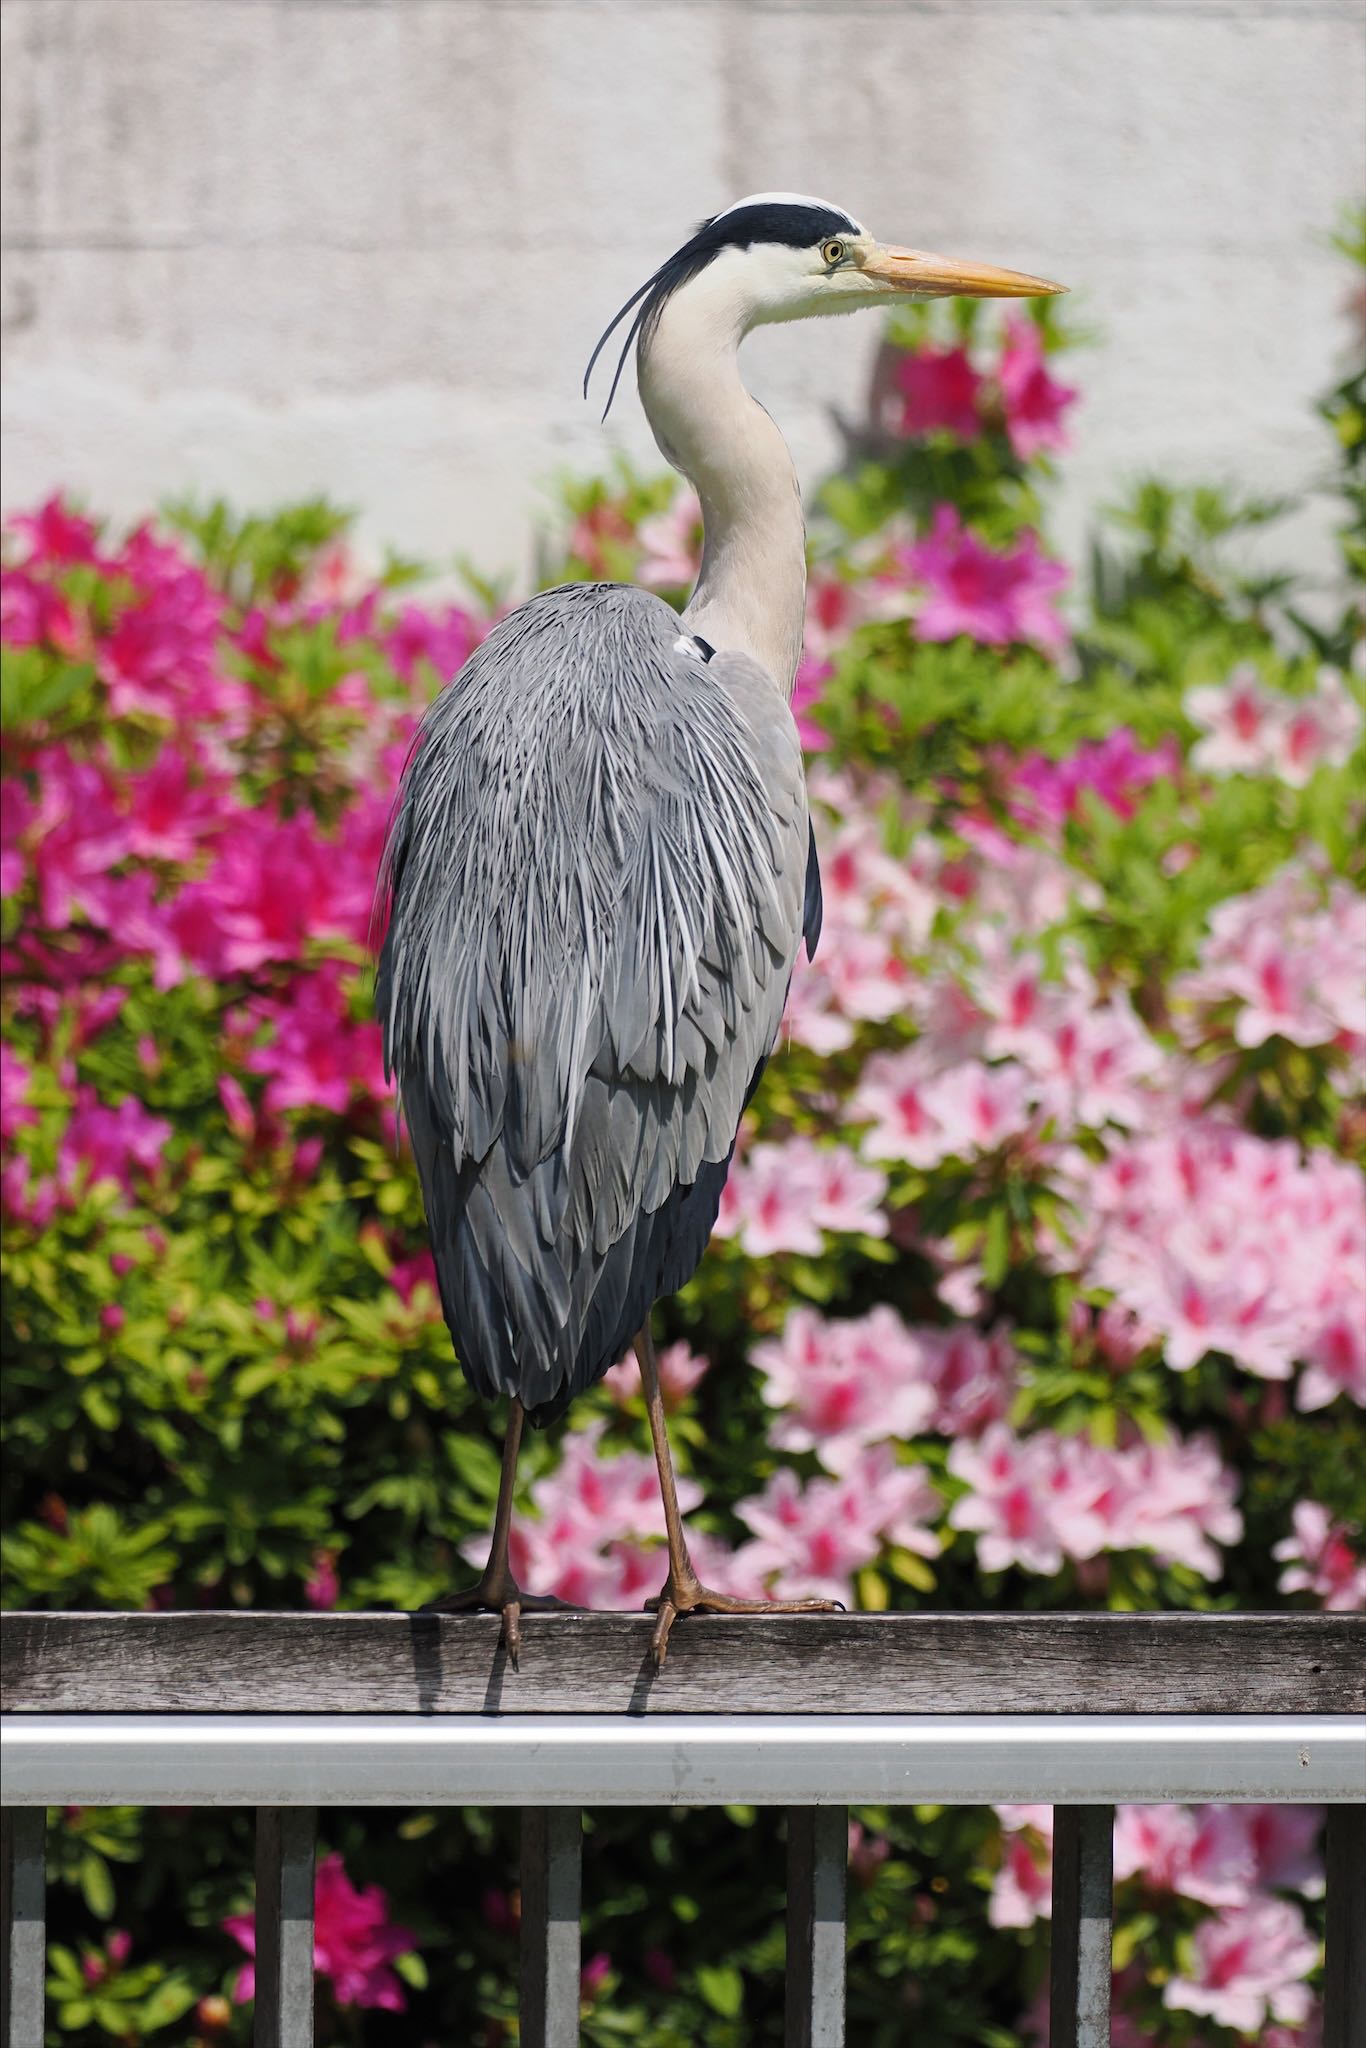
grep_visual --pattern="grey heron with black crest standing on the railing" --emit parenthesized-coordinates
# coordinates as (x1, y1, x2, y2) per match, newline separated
(377, 193, 1061, 1663)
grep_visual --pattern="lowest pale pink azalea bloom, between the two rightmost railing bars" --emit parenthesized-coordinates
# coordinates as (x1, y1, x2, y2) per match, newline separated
(1163, 1898, 1319, 2034)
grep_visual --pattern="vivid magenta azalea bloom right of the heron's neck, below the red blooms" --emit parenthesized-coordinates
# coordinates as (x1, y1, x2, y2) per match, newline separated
(901, 506, 1067, 653)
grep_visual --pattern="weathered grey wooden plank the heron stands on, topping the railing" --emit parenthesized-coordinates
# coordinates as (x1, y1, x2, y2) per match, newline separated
(0, 1614, 1366, 1714)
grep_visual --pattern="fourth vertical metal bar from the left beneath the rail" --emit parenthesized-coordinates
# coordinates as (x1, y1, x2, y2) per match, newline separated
(782, 1806, 850, 2048)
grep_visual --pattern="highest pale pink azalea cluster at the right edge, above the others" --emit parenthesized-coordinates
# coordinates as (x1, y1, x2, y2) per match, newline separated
(1186, 662, 1362, 788)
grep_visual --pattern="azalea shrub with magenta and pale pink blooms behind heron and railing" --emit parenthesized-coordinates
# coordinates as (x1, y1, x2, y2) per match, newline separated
(0, 228, 1366, 2048)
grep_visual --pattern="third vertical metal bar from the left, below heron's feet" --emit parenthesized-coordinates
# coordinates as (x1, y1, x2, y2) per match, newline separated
(520, 1806, 584, 2048)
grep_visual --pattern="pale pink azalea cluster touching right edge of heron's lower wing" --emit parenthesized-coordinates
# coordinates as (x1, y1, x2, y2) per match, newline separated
(713, 1139, 887, 1260)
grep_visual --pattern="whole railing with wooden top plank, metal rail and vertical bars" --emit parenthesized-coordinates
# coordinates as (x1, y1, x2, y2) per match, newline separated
(0, 1614, 1366, 2048)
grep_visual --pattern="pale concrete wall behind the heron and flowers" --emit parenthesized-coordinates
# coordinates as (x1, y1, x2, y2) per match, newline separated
(0, 0, 1366, 567)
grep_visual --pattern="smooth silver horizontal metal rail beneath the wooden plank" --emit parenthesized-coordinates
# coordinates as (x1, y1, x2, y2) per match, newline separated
(0, 1714, 1366, 1806)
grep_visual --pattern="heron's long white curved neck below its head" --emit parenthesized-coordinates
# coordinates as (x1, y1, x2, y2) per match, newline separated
(639, 262, 807, 696)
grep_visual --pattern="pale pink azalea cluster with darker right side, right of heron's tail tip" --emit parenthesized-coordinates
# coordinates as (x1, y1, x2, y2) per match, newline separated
(752, 1303, 1016, 1473)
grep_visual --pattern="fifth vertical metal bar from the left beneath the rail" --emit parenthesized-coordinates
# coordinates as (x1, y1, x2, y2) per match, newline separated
(1049, 1806, 1114, 2048)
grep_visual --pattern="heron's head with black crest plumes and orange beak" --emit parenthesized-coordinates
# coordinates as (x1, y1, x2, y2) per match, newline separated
(584, 193, 1067, 418)
